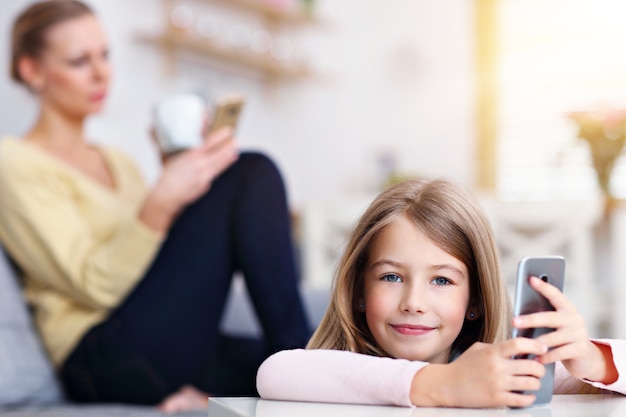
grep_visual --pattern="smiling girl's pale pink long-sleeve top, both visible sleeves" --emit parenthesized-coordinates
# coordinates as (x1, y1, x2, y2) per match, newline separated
(257, 339, 626, 407)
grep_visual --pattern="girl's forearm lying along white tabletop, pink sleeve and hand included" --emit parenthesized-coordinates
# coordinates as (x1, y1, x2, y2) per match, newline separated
(257, 338, 545, 407)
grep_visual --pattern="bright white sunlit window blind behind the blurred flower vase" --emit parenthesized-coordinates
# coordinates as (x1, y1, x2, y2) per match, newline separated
(496, 0, 626, 199)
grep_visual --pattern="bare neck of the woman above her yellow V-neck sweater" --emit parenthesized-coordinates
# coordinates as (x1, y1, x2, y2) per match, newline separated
(25, 107, 87, 152)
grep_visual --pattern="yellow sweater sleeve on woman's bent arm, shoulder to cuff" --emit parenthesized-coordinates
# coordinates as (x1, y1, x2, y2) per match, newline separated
(0, 150, 162, 309)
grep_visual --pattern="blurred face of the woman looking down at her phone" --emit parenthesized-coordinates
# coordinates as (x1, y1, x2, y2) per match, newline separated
(30, 14, 111, 117)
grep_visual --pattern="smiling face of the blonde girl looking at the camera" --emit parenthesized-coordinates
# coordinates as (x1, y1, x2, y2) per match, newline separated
(363, 216, 470, 363)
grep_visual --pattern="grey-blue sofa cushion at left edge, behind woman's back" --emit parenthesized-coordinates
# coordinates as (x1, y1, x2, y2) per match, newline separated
(0, 247, 63, 405)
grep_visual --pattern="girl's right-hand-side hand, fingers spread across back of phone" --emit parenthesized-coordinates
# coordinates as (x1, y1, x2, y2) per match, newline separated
(513, 277, 617, 383)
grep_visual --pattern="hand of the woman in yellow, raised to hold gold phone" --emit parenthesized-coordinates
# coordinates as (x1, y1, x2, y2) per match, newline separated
(140, 128, 239, 231)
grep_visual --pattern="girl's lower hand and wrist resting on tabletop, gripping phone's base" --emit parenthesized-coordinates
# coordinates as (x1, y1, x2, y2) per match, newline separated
(411, 338, 547, 408)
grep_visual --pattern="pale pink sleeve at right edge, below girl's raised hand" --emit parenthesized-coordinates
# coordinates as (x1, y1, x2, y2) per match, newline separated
(554, 339, 626, 395)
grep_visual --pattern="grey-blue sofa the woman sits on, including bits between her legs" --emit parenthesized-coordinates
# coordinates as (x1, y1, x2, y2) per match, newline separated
(0, 247, 328, 417)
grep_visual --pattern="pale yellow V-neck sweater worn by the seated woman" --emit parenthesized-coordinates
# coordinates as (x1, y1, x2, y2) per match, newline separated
(0, 138, 163, 366)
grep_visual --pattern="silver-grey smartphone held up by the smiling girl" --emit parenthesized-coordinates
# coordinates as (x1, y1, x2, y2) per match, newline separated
(512, 256, 565, 404)
